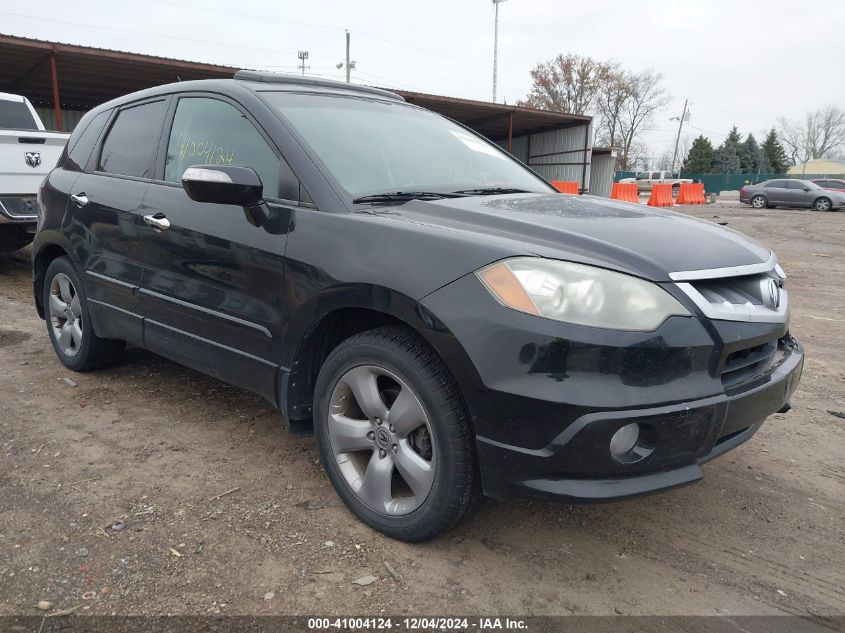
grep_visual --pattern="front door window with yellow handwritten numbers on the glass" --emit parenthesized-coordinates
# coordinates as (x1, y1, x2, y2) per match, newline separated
(164, 97, 299, 201)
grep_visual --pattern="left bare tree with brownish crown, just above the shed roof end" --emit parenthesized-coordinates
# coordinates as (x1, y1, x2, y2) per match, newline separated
(519, 53, 608, 114)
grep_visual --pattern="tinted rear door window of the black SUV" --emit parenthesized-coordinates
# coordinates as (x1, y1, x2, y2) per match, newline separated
(97, 100, 165, 178)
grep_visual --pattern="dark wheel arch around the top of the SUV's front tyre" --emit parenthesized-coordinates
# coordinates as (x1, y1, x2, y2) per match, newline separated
(278, 289, 481, 436)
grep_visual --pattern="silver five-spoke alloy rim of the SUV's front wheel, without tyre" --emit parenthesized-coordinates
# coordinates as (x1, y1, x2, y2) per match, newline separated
(328, 365, 436, 516)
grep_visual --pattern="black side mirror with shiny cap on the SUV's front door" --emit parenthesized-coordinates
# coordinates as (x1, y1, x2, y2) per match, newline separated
(182, 165, 269, 226)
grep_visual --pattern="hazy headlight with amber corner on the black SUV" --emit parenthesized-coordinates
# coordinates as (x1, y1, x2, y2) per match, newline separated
(475, 257, 690, 332)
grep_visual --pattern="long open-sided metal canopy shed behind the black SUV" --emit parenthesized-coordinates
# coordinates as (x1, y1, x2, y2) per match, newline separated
(0, 34, 592, 191)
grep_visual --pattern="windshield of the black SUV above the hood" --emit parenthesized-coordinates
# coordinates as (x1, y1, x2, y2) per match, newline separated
(263, 92, 551, 198)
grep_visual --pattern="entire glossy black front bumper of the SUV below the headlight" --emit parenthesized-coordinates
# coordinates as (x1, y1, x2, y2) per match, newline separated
(421, 278, 804, 502)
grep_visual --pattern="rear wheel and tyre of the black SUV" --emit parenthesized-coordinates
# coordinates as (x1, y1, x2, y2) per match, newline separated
(43, 257, 126, 371)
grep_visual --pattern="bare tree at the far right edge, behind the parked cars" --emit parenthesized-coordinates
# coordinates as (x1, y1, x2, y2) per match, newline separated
(778, 105, 845, 164)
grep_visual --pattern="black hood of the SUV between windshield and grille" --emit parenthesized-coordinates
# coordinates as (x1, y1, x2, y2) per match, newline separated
(386, 194, 771, 281)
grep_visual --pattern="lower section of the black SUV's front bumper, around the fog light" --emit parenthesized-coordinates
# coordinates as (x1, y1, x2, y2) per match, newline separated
(478, 342, 804, 503)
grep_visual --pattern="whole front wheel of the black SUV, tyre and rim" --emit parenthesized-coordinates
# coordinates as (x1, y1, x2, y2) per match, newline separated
(314, 327, 481, 542)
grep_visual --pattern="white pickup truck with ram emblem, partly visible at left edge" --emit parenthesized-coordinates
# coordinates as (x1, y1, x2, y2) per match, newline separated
(0, 92, 70, 253)
